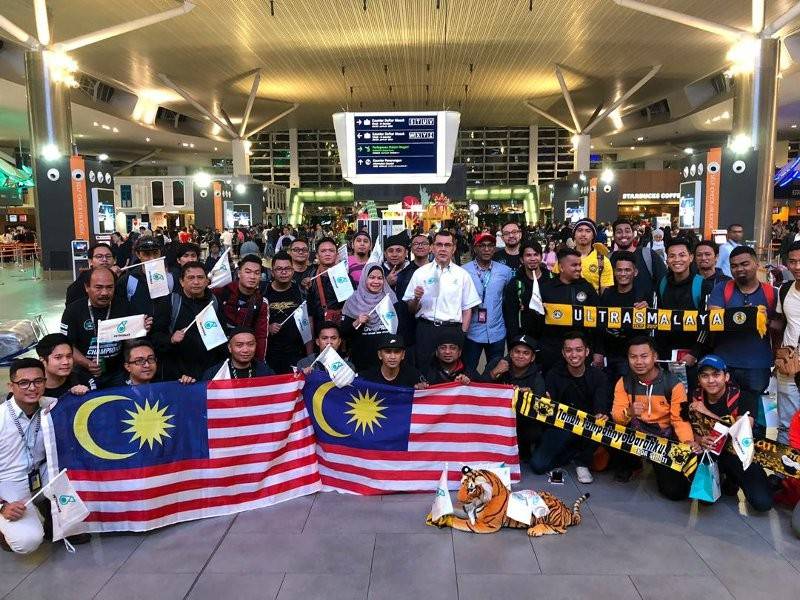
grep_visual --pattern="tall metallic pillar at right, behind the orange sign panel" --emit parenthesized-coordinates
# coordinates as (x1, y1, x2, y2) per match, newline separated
(732, 39, 781, 260)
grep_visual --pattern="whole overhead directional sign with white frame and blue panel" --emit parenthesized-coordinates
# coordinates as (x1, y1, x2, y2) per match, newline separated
(333, 111, 461, 184)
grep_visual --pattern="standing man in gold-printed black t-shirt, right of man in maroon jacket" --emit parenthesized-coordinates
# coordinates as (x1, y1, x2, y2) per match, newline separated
(264, 251, 313, 375)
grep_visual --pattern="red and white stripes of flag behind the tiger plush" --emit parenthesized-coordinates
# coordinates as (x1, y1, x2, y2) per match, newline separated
(317, 383, 520, 494)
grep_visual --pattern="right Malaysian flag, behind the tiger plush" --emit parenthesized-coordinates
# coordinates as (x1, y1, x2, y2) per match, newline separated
(303, 371, 520, 494)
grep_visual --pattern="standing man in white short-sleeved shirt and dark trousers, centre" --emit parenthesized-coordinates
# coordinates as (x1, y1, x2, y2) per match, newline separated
(403, 230, 481, 366)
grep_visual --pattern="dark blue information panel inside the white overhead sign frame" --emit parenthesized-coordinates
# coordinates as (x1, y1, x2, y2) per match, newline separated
(354, 113, 438, 175)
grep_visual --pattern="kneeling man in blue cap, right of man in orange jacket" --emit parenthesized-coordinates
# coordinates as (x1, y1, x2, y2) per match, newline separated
(689, 354, 772, 512)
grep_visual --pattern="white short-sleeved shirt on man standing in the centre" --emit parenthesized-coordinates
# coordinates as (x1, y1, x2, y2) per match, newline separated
(403, 262, 481, 323)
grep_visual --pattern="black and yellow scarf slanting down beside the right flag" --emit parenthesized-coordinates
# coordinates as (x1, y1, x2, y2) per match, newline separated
(514, 391, 697, 477)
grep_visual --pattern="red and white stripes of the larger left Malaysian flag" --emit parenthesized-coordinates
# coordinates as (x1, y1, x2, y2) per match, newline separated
(43, 375, 321, 532)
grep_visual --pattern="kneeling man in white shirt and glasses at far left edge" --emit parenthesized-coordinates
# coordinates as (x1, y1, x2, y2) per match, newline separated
(0, 358, 47, 554)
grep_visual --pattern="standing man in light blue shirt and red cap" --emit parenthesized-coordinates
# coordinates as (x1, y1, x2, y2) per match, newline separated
(462, 233, 514, 371)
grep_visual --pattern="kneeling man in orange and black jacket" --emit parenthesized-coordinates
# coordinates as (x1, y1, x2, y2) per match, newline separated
(611, 336, 700, 501)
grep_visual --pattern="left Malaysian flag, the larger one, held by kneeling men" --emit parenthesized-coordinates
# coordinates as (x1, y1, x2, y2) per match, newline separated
(42, 375, 321, 532)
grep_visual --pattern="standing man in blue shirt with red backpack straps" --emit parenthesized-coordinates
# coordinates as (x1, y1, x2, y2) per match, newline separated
(708, 246, 776, 396)
